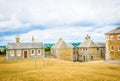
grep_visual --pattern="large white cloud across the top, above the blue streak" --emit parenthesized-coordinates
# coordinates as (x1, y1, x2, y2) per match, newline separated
(0, 0, 120, 28)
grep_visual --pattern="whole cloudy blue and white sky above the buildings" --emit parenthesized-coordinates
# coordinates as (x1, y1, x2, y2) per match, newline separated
(0, 0, 120, 45)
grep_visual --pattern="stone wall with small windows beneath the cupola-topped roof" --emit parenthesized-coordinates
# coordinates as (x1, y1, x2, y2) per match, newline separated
(78, 48, 105, 61)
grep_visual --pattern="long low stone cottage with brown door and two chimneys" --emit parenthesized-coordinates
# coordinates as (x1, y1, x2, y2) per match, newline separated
(6, 37, 44, 60)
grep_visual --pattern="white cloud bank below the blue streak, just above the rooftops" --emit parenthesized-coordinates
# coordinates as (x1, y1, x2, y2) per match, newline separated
(2, 26, 115, 43)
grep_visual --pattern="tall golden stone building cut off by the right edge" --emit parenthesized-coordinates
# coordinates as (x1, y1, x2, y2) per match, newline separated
(105, 27, 120, 60)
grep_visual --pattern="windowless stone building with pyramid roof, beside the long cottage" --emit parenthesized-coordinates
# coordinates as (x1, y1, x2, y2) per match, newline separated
(51, 38, 73, 61)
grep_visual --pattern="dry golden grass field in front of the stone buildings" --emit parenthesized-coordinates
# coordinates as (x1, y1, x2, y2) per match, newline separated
(0, 56, 120, 81)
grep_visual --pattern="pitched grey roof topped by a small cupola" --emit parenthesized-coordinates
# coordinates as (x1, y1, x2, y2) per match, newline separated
(78, 35, 105, 47)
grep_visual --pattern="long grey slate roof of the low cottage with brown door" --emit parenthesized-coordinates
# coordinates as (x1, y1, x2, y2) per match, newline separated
(6, 42, 43, 49)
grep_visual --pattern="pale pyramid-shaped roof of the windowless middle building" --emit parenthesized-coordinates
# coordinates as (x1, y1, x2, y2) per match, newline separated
(52, 38, 73, 49)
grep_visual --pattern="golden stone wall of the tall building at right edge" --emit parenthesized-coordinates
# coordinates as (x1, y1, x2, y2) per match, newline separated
(106, 34, 120, 60)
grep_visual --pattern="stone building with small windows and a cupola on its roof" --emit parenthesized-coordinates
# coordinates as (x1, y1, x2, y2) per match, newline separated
(76, 35, 105, 61)
